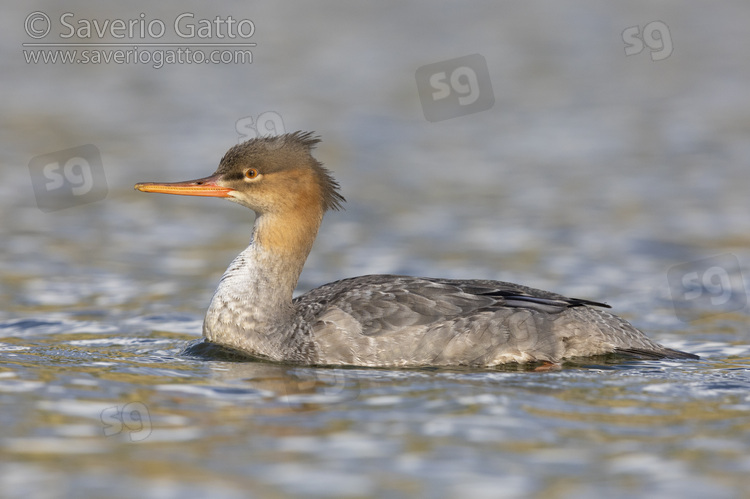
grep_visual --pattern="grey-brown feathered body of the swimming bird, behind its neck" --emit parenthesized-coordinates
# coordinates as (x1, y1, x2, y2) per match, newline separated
(295, 275, 700, 366)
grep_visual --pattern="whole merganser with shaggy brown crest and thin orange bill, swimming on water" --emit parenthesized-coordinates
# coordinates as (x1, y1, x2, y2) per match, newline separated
(135, 132, 698, 367)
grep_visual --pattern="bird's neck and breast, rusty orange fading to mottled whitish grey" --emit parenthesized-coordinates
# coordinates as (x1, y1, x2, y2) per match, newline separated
(203, 208, 322, 358)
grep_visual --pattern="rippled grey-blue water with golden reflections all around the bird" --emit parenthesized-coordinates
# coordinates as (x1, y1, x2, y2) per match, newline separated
(0, 0, 750, 497)
